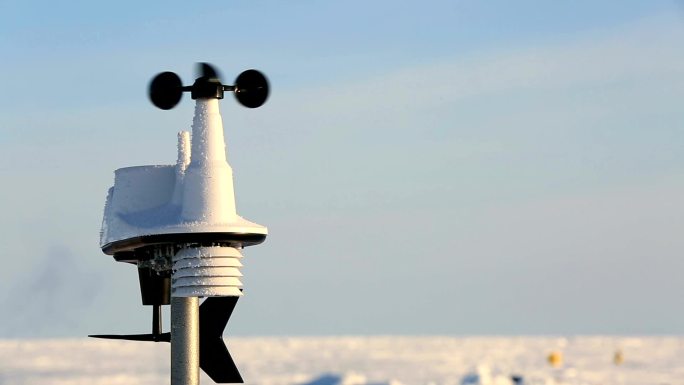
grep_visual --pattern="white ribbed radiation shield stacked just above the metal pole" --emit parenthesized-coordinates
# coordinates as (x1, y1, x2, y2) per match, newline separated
(171, 246, 242, 297)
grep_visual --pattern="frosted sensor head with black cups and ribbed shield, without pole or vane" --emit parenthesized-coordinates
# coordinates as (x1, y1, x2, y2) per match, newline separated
(100, 65, 268, 304)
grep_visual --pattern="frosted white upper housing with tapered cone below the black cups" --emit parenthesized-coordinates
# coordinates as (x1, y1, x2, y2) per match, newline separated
(100, 99, 268, 246)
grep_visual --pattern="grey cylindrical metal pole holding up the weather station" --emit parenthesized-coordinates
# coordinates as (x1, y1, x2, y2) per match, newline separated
(171, 297, 199, 385)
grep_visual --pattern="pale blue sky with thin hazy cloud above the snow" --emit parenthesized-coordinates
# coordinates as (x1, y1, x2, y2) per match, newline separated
(0, 1, 684, 337)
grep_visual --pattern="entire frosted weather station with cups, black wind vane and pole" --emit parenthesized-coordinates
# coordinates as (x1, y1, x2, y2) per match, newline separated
(91, 63, 269, 385)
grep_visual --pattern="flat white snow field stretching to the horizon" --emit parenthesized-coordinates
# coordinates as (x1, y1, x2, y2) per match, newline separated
(0, 336, 684, 385)
